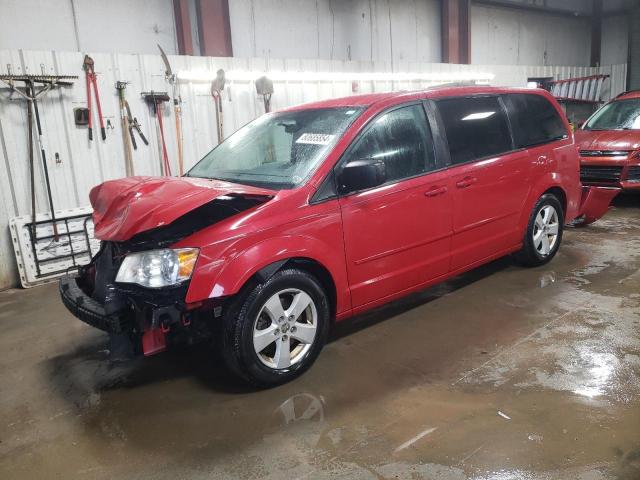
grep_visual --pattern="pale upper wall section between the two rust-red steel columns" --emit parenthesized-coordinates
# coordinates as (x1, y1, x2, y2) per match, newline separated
(229, 0, 441, 62)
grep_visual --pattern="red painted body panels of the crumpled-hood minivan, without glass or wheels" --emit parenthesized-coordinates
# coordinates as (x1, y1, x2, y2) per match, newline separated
(91, 87, 610, 319)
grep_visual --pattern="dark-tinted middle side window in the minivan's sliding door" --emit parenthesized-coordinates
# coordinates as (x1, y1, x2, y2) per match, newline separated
(436, 97, 513, 164)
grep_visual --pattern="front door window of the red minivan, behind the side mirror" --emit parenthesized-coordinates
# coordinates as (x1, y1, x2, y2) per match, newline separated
(349, 105, 436, 181)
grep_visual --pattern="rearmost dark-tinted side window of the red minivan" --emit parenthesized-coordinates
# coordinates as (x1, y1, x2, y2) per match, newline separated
(503, 93, 567, 148)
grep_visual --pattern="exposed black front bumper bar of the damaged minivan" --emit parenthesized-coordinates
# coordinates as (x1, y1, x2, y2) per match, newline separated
(59, 275, 132, 333)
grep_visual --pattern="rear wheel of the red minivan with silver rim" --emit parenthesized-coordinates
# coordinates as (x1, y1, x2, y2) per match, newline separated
(518, 193, 564, 267)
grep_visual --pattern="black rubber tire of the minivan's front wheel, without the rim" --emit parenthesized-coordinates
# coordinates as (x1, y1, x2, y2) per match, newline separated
(222, 268, 330, 387)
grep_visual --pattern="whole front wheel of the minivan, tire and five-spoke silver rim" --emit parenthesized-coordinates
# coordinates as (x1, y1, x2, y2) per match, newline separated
(222, 269, 330, 387)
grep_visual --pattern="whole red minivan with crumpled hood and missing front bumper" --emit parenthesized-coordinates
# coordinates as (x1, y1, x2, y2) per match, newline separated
(60, 87, 617, 386)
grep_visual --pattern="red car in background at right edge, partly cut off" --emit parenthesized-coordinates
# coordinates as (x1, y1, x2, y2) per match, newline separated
(575, 91, 640, 189)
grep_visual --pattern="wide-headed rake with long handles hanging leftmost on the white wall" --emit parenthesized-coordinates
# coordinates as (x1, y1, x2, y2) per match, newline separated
(0, 67, 78, 242)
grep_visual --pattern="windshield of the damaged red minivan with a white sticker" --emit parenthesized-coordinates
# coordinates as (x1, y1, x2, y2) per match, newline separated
(187, 107, 363, 190)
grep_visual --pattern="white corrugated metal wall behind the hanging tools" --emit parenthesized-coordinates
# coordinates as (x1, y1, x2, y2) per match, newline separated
(0, 50, 626, 289)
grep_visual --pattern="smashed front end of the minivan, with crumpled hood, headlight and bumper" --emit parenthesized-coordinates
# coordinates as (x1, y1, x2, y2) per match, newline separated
(60, 178, 272, 355)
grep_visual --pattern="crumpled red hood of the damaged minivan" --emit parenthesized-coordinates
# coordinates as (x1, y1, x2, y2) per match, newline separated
(89, 177, 274, 241)
